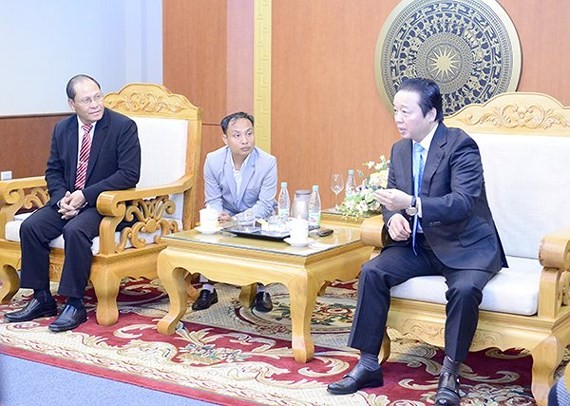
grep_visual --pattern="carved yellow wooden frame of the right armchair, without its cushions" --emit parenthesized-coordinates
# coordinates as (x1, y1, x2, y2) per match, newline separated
(361, 92, 570, 405)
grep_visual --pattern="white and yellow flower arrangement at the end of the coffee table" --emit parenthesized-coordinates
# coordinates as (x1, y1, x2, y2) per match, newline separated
(338, 155, 390, 217)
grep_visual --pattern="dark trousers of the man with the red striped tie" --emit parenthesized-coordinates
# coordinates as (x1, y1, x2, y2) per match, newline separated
(20, 206, 102, 298)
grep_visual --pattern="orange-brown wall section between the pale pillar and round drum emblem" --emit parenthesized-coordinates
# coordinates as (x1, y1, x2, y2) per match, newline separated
(272, 0, 397, 206)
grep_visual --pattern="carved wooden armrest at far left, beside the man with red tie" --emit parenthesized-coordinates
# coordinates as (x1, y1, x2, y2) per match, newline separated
(0, 176, 49, 239)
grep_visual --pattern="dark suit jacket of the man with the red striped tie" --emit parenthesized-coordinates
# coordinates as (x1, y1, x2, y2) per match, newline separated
(46, 109, 141, 206)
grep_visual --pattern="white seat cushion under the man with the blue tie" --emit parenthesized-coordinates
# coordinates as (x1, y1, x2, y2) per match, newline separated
(391, 257, 542, 316)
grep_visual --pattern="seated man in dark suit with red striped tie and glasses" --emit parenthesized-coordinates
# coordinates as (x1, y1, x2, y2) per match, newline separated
(4, 75, 141, 332)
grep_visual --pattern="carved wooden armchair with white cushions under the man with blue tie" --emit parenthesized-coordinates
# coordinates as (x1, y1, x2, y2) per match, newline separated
(361, 92, 570, 405)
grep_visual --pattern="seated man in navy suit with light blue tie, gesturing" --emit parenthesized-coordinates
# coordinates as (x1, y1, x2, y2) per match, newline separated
(328, 79, 507, 405)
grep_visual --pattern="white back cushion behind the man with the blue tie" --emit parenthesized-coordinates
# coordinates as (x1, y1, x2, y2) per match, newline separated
(470, 133, 570, 258)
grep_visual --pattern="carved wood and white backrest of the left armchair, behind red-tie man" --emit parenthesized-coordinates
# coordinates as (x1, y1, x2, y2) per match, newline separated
(105, 83, 202, 229)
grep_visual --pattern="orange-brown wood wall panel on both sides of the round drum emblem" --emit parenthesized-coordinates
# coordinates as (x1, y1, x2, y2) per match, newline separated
(271, 0, 570, 206)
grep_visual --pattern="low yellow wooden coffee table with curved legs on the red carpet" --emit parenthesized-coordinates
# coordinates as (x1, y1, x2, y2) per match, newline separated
(157, 222, 372, 362)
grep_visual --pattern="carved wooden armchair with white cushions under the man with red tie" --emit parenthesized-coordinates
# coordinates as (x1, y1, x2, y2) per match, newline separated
(0, 84, 202, 325)
